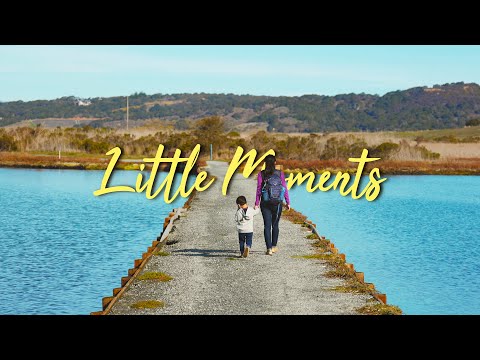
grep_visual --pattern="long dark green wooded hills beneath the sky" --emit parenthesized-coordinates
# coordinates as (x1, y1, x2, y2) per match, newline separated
(0, 82, 480, 132)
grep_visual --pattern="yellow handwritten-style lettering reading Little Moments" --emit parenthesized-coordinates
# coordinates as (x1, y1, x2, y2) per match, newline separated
(93, 144, 387, 204)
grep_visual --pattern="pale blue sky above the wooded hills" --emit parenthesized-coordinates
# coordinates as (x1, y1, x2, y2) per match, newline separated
(0, 45, 480, 101)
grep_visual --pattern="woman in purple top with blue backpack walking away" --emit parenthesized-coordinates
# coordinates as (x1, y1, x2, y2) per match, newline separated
(254, 155, 290, 255)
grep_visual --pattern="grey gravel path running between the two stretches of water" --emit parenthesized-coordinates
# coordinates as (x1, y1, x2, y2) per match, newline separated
(110, 162, 371, 315)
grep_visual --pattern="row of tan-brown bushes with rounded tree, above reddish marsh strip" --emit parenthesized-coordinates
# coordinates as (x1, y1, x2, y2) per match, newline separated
(0, 116, 440, 161)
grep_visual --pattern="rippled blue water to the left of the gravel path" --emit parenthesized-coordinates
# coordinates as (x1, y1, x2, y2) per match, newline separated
(0, 169, 190, 314)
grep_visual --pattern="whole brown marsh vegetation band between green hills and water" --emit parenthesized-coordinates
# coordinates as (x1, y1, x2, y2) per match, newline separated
(0, 117, 480, 174)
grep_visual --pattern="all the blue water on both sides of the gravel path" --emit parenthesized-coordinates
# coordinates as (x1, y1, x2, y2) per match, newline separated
(0, 169, 480, 314)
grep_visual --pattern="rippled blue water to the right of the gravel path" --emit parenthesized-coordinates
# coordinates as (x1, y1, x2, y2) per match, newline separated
(291, 176, 480, 314)
